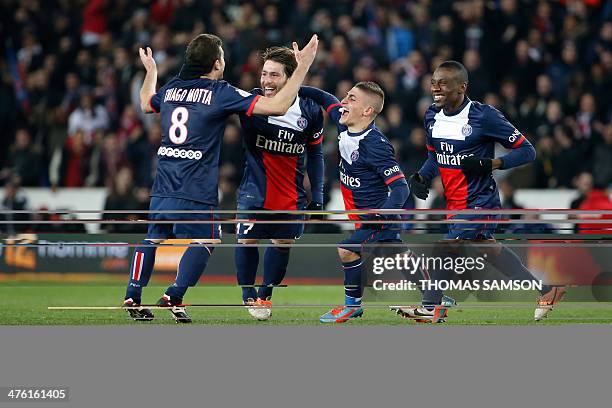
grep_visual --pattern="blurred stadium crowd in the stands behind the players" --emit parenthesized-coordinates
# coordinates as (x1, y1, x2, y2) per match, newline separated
(0, 0, 612, 230)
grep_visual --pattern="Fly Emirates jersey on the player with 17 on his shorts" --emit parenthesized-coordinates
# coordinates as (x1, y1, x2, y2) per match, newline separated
(238, 89, 323, 210)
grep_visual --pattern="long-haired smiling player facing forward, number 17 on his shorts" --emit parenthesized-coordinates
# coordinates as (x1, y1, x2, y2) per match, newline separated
(235, 47, 324, 320)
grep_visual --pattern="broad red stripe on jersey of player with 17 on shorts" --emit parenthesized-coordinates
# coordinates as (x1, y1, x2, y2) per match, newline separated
(263, 152, 298, 210)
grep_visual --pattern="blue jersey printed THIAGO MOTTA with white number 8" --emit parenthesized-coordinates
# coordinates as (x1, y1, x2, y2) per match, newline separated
(150, 77, 260, 206)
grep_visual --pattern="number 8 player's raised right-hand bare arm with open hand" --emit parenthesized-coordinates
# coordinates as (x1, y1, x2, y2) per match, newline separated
(252, 34, 319, 116)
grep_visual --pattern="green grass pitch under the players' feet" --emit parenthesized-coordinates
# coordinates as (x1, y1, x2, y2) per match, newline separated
(0, 282, 612, 326)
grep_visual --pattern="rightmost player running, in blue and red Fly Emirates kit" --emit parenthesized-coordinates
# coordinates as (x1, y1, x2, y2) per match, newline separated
(396, 61, 565, 322)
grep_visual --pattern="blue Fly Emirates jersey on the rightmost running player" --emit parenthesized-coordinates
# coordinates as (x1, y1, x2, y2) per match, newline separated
(424, 97, 529, 209)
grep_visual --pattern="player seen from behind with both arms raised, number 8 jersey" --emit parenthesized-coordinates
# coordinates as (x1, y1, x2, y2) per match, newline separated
(124, 34, 318, 323)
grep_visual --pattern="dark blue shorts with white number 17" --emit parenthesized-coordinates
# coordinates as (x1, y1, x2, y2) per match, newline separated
(236, 208, 304, 239)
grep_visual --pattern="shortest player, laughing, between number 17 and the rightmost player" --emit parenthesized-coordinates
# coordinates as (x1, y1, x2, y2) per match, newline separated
(300, 82, 408, 323)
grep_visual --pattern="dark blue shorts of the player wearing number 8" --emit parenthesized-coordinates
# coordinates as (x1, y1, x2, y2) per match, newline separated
(147, 197, 221, 239)
